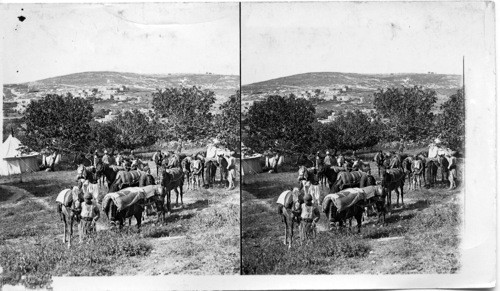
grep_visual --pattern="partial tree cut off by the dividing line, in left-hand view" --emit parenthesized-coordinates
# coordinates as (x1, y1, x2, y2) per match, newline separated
(213, 90, 241, 152)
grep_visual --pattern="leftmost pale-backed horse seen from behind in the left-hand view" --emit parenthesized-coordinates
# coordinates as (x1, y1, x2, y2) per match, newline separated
(56, 186, 83, 248)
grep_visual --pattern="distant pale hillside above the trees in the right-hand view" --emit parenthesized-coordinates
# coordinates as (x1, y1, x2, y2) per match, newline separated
(242, 72, 462, 96)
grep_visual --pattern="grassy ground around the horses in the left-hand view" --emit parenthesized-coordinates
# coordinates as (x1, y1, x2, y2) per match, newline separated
(0, 162, 240, 287)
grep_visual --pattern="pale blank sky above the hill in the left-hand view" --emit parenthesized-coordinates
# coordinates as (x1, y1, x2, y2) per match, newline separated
(0, 3, 239, 83)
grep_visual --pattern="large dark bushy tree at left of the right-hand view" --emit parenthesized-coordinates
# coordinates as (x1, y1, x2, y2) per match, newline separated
(244, 94, 315, 153)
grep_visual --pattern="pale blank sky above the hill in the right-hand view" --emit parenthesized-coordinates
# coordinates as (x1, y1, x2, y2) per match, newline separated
(241, 2, 486, 84)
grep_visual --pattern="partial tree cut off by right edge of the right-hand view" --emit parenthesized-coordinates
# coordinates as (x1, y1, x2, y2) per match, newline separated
(437, 90, 465, 149)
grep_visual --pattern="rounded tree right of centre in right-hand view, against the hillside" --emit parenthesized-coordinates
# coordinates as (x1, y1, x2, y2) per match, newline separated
(374, 86, 437, 140)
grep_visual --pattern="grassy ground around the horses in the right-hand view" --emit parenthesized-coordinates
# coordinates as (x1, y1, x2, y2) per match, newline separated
(241, 160, 463, 274)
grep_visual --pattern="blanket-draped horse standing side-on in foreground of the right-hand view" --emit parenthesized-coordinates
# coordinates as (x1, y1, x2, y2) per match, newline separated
(323, 185, 386, 233)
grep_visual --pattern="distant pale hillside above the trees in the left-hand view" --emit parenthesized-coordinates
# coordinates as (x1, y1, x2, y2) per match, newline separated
(4, 72, 239, 95)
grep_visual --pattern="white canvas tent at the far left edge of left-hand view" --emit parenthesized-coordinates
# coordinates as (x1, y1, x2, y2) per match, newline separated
(0, 135, 39, 176)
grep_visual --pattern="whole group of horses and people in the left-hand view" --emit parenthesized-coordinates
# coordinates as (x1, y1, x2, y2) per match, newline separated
(56, 152, 231, 246)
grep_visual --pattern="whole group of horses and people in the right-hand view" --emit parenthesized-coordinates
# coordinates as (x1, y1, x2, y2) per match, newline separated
(277, 151, 458, 247)
